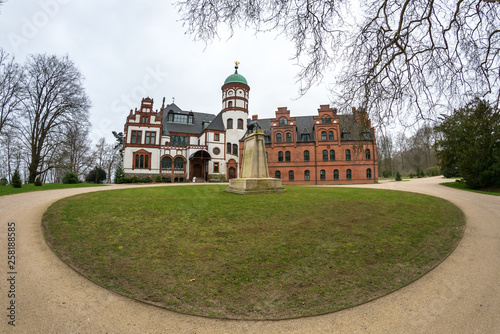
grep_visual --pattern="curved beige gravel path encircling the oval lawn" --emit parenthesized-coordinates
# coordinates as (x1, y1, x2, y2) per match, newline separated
(0, 177, 500, 334)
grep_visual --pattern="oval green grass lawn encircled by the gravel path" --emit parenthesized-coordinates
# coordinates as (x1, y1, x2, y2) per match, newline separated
(42, 185, 465, 319)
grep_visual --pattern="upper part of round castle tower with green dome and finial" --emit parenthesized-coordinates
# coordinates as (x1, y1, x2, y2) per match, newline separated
(222, 62, 250, 114)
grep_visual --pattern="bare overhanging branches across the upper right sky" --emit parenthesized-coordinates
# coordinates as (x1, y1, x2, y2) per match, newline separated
(177, 0, 500, 123)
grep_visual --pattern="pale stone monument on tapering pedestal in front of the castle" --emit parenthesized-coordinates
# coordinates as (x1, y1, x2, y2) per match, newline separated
(226, 125, 285, 194)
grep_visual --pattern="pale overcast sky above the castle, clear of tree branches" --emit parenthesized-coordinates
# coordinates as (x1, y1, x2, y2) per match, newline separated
(0, 0, 332, 142)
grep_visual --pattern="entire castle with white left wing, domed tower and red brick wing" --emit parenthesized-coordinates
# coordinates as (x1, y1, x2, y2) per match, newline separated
(123, 63, 378, 185)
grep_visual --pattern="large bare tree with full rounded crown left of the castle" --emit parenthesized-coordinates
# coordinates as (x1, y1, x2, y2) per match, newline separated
(21, 55, 90, 183)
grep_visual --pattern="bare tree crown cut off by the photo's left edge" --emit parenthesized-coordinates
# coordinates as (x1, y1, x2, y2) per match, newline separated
(0, 48, 22, 133)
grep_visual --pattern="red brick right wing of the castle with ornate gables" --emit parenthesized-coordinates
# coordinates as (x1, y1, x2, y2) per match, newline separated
(240, 105, 378, 185)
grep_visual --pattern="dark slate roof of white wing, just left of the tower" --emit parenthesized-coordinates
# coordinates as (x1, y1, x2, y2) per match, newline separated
(163, 103, 216, 135)
